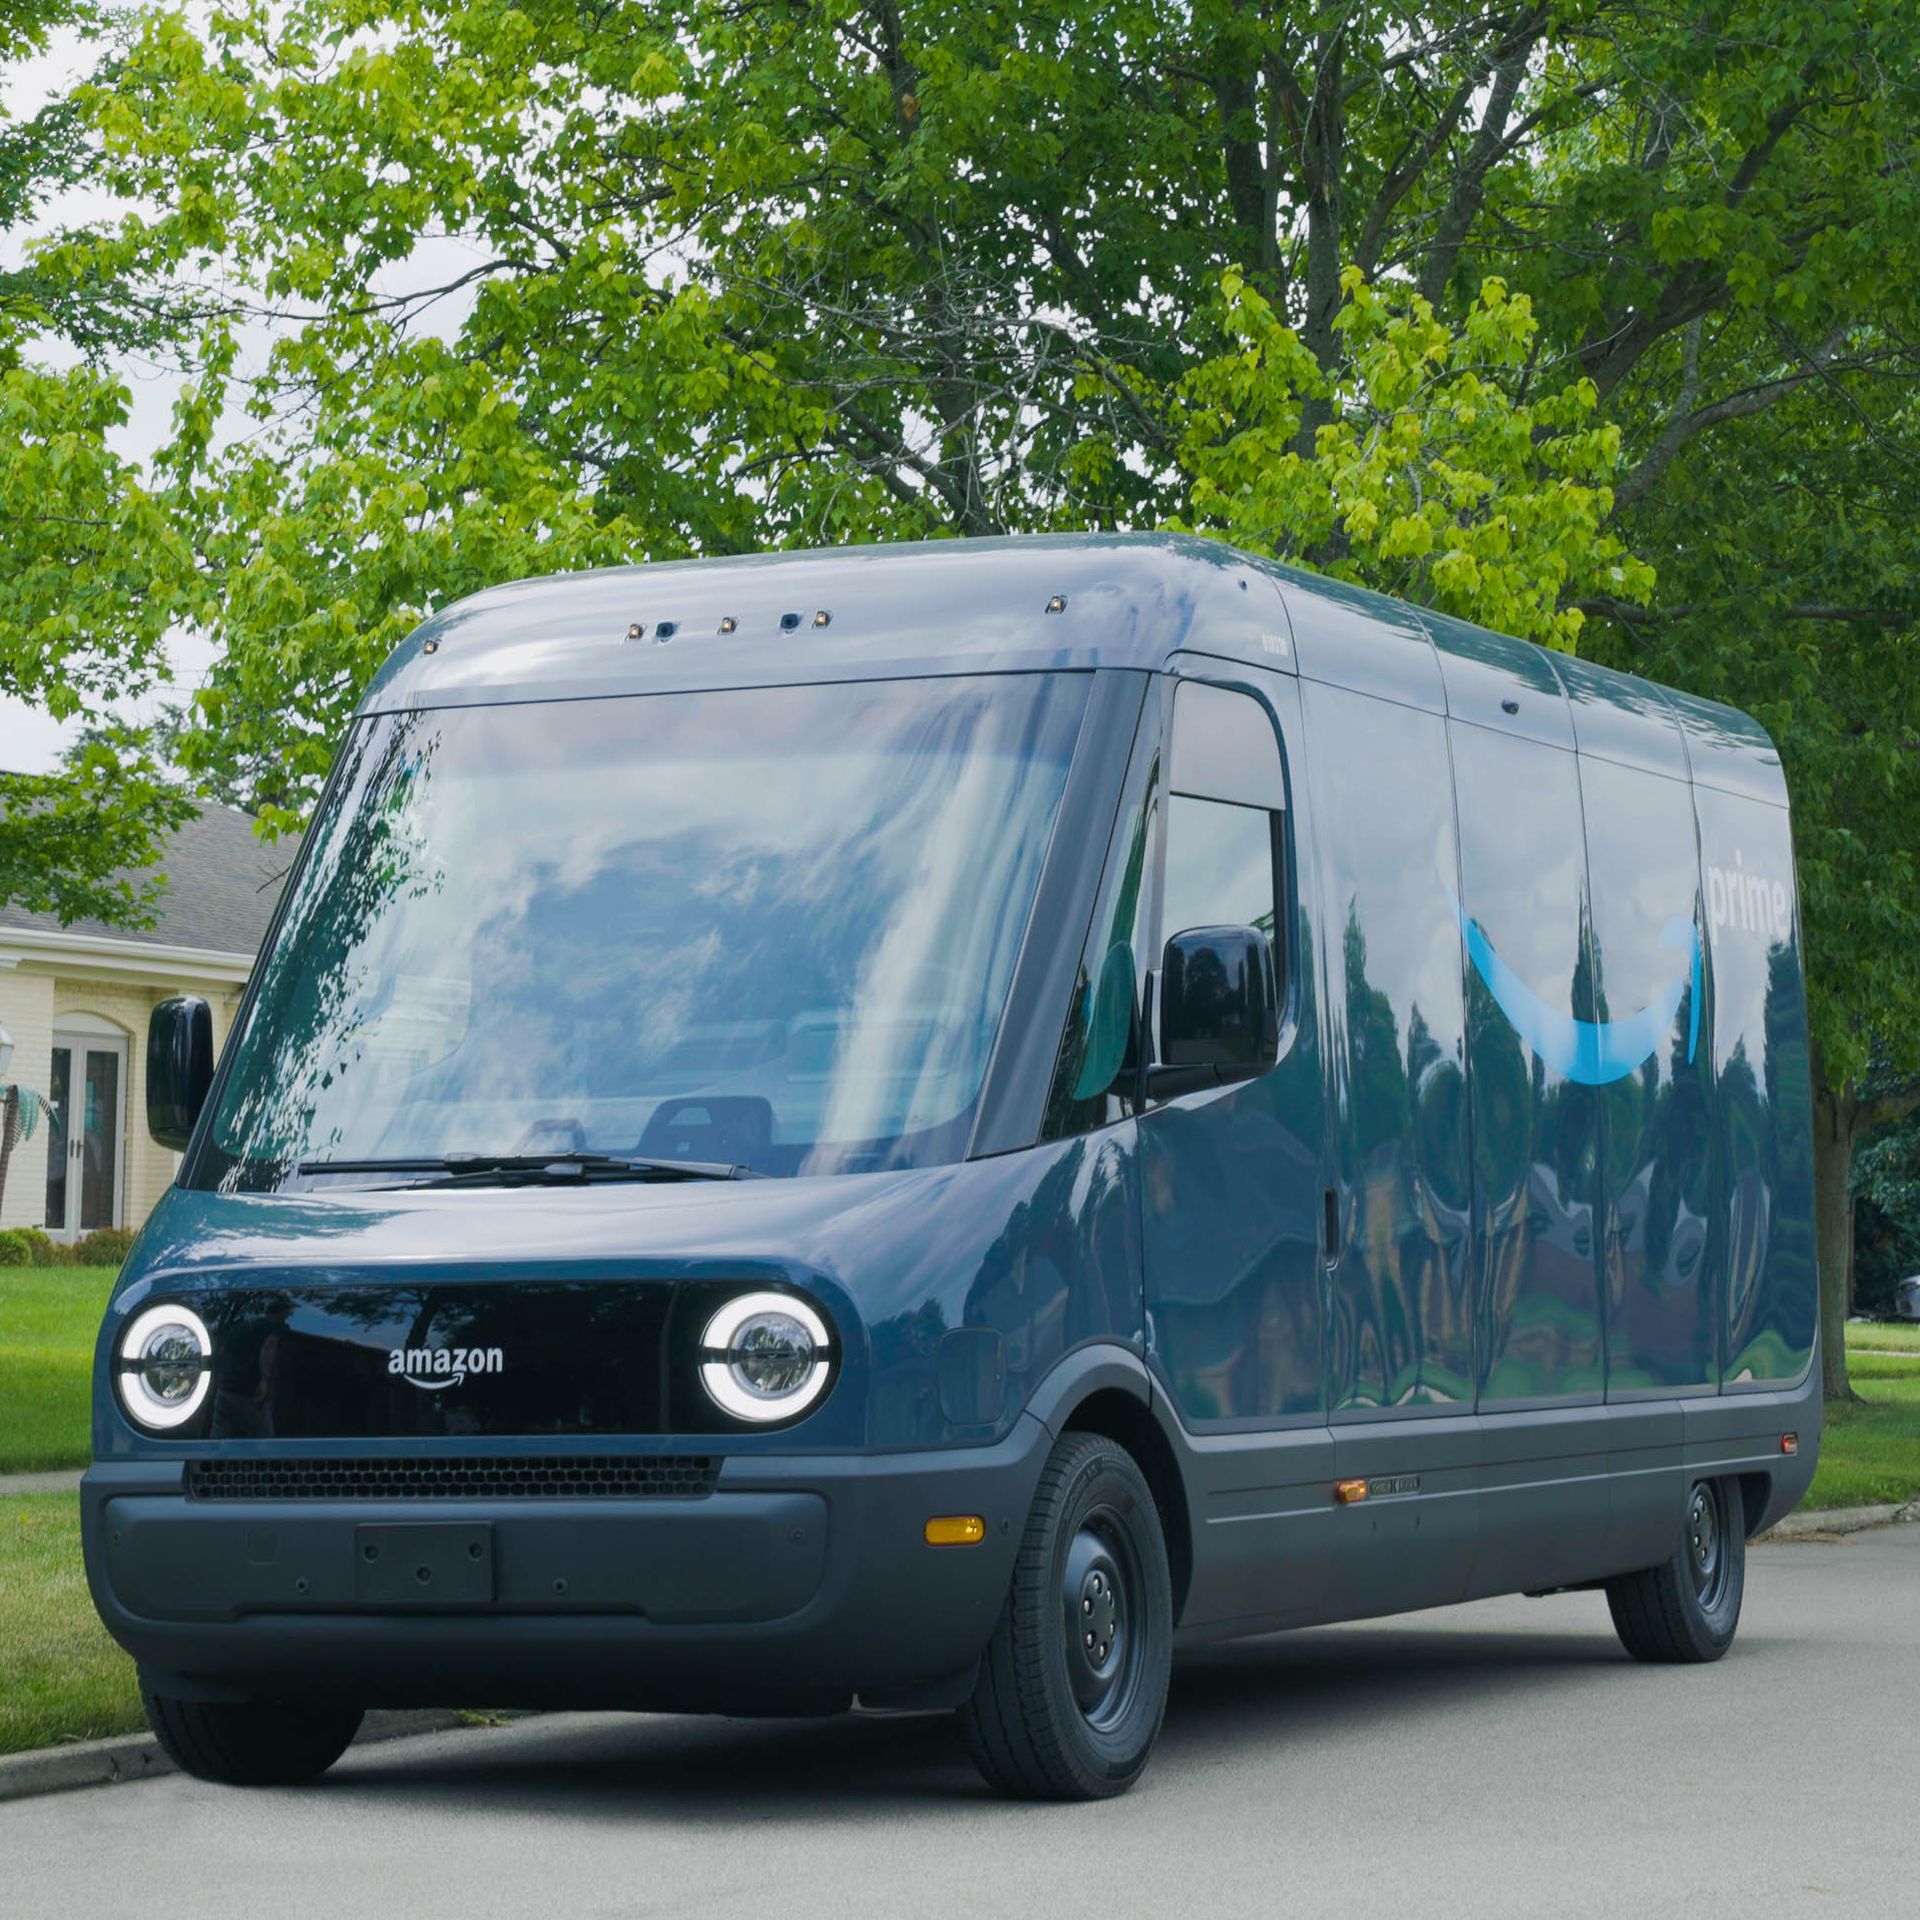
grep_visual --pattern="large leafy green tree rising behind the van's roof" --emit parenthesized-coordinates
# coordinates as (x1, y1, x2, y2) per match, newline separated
(94, 0, 1920, 1386)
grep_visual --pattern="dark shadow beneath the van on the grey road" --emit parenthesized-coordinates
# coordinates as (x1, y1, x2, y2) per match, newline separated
(324, 1626, 1632, 1826)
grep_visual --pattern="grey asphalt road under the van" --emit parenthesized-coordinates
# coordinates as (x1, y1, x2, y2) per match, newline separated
(0, 1526, 1920, 1920)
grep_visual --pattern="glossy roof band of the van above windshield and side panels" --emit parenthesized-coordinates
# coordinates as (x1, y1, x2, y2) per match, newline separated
(361, 534, 1786, 803)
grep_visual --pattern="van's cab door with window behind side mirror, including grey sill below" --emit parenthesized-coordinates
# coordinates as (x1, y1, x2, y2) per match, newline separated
(1139, 660, 1329, 1622)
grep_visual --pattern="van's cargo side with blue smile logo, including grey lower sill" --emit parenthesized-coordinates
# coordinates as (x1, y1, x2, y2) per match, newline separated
(1146, 582, 1820, 1638)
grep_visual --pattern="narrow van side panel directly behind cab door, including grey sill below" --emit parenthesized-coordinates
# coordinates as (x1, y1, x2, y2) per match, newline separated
(1304, 684, 1480, 1617)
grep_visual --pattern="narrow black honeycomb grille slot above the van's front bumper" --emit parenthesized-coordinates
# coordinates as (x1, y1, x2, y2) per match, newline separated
(186, 1453, 720, 1500)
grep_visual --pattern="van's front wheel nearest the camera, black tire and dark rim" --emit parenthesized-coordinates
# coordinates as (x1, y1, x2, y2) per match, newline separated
(960, 1434, 1173, 1801)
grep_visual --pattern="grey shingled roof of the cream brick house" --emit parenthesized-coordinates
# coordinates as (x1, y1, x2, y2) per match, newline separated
(0, 806, 300, 960)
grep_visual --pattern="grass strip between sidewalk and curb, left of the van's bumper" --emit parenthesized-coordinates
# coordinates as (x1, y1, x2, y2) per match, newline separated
(0, 1497, 146, 1753)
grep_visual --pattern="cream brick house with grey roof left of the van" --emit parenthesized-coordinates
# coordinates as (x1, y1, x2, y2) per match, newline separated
(0, 806, 298, 1240)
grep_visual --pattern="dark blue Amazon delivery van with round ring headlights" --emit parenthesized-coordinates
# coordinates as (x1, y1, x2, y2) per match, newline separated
(83, 538, 1820, 1797)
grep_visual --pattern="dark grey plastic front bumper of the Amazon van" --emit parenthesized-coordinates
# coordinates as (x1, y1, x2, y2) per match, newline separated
(81, 1415, 1052, 1713)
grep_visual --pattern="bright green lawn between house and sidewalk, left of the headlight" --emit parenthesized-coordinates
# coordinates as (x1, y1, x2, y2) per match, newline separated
(0, 1267, 119, 1473)
